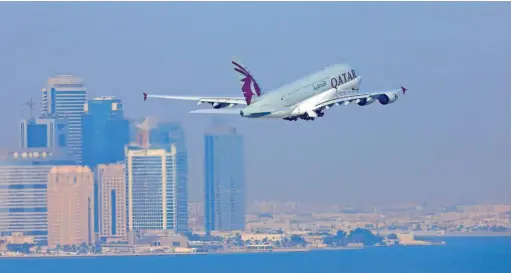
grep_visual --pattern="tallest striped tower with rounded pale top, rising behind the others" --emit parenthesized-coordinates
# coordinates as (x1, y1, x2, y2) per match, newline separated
(41, 75, 87, 164)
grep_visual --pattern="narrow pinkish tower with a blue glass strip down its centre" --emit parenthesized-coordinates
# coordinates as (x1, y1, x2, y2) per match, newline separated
(96, 164, 127, 241)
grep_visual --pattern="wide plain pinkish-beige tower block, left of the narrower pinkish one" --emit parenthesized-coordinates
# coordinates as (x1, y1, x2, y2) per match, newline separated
(48, 166, 95, 247)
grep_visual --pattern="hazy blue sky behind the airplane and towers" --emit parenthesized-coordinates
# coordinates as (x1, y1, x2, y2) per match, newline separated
(0, 2, 511, 203)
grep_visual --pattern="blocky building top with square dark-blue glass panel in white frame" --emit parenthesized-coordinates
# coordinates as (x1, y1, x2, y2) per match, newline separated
(20, 118, 67, 149)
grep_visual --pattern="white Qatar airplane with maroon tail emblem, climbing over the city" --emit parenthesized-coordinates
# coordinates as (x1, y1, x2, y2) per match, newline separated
(144, 60, 407, 121)
